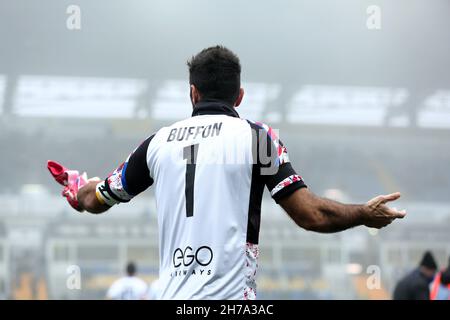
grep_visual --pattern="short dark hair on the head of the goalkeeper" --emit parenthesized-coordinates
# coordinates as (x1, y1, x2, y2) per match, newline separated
(187, 45, 241, 104)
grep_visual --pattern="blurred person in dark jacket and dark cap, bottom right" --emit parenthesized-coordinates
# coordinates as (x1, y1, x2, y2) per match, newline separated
(394, 251, 438, 300)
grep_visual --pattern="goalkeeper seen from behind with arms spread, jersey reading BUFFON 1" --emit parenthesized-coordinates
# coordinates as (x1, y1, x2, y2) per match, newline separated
(49, 46, 406, 299)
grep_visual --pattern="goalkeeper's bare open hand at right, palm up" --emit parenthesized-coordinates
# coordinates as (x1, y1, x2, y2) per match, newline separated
(362, 192, 406, 229)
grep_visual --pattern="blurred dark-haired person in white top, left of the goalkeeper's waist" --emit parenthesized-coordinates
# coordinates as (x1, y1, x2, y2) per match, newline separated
(106, 262, 147, 300)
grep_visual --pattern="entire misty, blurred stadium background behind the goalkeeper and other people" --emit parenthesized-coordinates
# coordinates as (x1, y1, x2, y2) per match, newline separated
(0, 0, 450, 299)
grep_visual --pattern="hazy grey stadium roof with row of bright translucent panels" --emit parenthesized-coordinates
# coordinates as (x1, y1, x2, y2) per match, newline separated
(0, 0, 450, 128)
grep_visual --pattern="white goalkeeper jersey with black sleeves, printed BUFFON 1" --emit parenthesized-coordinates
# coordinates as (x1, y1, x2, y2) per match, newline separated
(102, 101, 305, 299)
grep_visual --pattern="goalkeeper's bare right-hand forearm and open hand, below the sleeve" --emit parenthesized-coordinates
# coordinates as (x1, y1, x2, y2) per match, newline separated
(279, 188, 406, 233)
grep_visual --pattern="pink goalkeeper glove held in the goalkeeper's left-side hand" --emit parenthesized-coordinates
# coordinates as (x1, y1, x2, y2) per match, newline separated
(47, 160, 88, 212)
